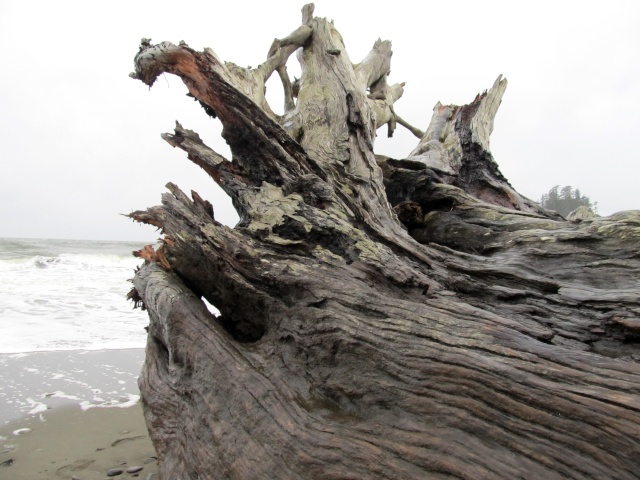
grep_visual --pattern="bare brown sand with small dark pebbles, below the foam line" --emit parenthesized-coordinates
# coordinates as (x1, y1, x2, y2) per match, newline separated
(0, 402, 158, 480)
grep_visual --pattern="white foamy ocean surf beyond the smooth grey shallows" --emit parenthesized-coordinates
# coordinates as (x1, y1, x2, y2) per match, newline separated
(0, 238, 148, 353)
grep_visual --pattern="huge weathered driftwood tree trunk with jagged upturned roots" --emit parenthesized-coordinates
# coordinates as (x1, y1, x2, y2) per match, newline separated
(131, 5, 640, 480)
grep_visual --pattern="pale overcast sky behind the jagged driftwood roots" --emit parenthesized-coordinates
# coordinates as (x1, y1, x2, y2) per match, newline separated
(0, 0, 640, 240)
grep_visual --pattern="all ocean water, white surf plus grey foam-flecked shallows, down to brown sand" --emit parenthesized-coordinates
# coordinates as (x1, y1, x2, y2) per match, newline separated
(0, 238, 156, 424)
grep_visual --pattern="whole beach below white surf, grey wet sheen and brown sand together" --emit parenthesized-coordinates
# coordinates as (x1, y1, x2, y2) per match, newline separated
(0, 350, 158, 480)
